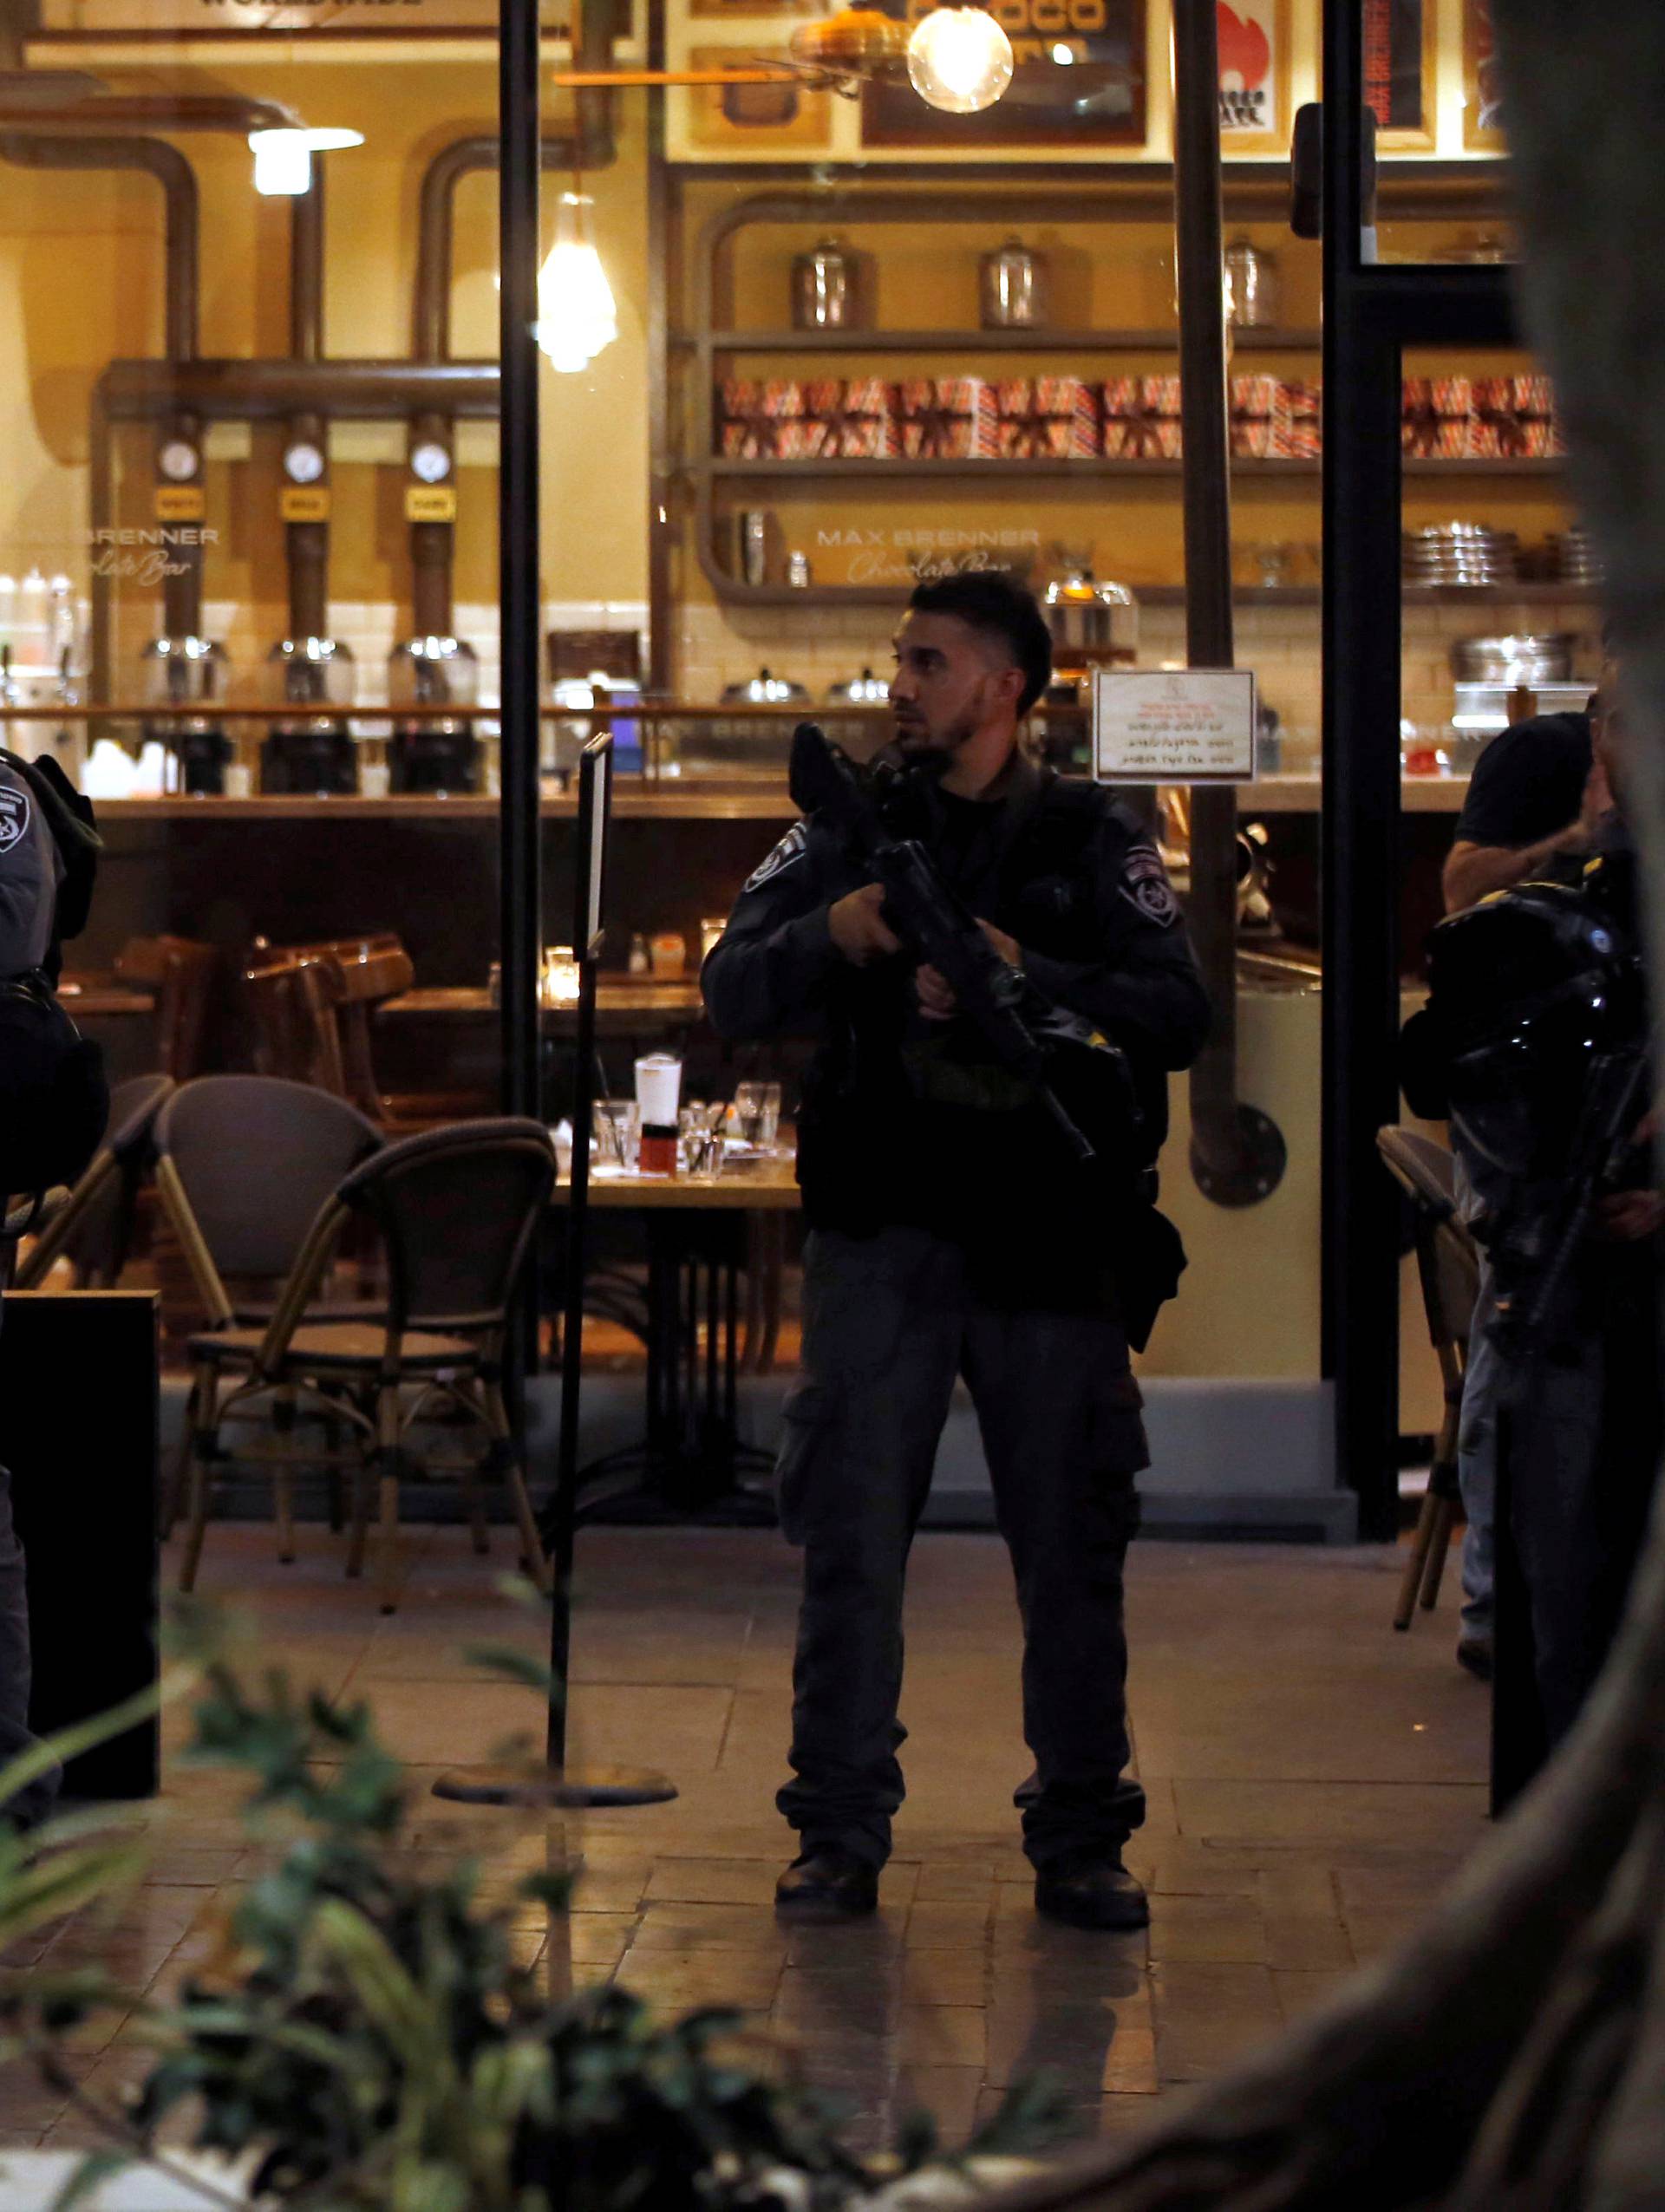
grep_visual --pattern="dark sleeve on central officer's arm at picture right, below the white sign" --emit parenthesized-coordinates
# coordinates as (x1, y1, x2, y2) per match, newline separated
(1024, 814, 1210, 1068)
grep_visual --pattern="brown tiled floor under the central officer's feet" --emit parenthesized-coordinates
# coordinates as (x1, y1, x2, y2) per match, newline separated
(0, 1526, 1485, 2145)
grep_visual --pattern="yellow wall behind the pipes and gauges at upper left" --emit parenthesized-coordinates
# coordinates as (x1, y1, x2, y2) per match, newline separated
(0, 64, 648, 662)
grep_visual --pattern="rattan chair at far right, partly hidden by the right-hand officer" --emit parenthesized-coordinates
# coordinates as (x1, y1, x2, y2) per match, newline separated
(1375, 1128, 1479, 1628)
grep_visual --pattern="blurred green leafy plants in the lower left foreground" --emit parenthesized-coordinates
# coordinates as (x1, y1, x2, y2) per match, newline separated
(0, 1608, 1061, 2212)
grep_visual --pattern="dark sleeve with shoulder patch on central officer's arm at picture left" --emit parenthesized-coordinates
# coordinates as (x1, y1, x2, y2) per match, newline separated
(699, 823, 849, 1044)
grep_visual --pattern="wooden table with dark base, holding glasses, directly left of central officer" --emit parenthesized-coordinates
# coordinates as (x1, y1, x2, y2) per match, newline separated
(552, 1144, 798, 1522)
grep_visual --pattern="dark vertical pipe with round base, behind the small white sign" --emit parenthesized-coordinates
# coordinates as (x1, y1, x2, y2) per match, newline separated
(1174, 0, 1287, 1205)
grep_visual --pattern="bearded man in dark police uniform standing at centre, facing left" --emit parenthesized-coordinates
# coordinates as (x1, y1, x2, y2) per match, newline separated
(703, 575, 1207, 1927)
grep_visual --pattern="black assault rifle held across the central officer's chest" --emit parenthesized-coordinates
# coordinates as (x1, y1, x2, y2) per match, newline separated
(789, 721, 1137, 1164)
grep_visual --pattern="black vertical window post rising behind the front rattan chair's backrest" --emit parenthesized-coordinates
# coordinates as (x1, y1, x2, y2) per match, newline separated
(498, 0, 542, 1117)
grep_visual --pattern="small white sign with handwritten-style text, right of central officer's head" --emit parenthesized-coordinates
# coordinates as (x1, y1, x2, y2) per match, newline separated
(1093, 668, 1256, 783)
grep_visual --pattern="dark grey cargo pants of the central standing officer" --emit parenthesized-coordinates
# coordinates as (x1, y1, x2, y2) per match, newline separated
(776, 1228, 1150, 1867)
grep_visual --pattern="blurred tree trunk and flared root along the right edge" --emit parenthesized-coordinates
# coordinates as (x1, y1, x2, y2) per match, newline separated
(972, 0, 1665, 2212)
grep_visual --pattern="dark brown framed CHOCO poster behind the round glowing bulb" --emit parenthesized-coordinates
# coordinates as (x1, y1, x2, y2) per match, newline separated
(862, 0, 1146, 153)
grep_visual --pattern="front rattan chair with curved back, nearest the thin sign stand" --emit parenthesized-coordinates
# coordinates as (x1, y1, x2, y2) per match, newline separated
(180, 1119, 555, 1613)
